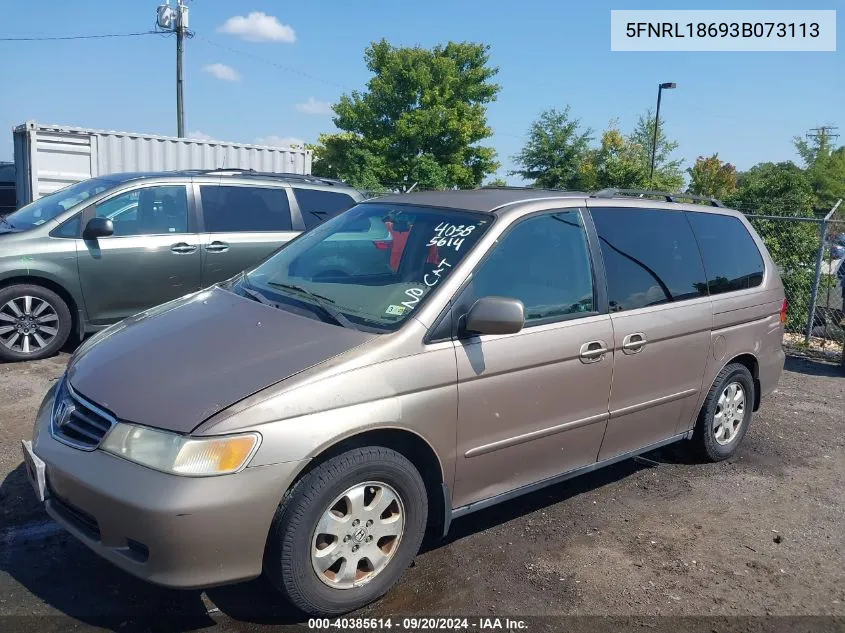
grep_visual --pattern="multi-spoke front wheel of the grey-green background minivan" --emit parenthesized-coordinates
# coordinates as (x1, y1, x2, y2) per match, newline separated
(0, 284, 73, 362)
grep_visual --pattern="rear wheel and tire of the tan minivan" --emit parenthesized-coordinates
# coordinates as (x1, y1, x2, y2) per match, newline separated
(693, 363, 756, 462)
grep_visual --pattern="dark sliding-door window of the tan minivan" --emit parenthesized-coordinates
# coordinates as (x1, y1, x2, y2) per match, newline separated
(591, 208, 707, 312)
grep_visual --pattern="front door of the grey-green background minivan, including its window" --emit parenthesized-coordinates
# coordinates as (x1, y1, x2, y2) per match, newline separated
(77, 185, 201, 325)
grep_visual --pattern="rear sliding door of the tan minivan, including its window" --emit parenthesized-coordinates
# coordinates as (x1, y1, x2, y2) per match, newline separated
(590, 208, 712, 460)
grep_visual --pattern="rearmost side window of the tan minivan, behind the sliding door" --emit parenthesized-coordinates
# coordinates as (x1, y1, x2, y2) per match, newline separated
(687, 212, 763, 295)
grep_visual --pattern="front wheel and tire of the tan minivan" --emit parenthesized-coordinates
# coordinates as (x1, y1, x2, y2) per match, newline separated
(264, 447, 428, 616)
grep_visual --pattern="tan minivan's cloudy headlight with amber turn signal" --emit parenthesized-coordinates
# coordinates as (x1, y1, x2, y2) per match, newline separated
(100, 423, 261, 477)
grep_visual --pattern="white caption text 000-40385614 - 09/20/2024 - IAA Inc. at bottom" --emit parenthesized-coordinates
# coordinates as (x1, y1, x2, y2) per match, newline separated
(308, 617, 528, 631)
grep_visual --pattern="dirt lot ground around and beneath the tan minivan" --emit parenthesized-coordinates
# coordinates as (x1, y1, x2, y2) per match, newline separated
(0, 355, 845, 632)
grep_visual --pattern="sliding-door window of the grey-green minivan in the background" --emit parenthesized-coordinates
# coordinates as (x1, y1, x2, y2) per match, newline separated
(200, 185, 291, 233)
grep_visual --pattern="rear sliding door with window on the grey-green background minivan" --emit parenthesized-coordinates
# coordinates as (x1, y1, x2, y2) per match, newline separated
(199, 184, 298, 286)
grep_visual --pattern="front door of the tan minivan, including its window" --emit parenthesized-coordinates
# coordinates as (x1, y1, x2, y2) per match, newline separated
(453, 209, 613, 507)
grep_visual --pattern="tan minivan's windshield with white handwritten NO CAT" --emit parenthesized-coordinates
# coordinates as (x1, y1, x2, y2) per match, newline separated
(232, 203, 493, 332)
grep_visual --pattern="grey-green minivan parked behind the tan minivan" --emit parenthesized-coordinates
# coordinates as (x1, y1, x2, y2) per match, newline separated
(0, 170, 360, 361)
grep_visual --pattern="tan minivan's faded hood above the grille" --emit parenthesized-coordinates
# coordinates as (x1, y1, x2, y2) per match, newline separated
(68, 288, 377, 433)
